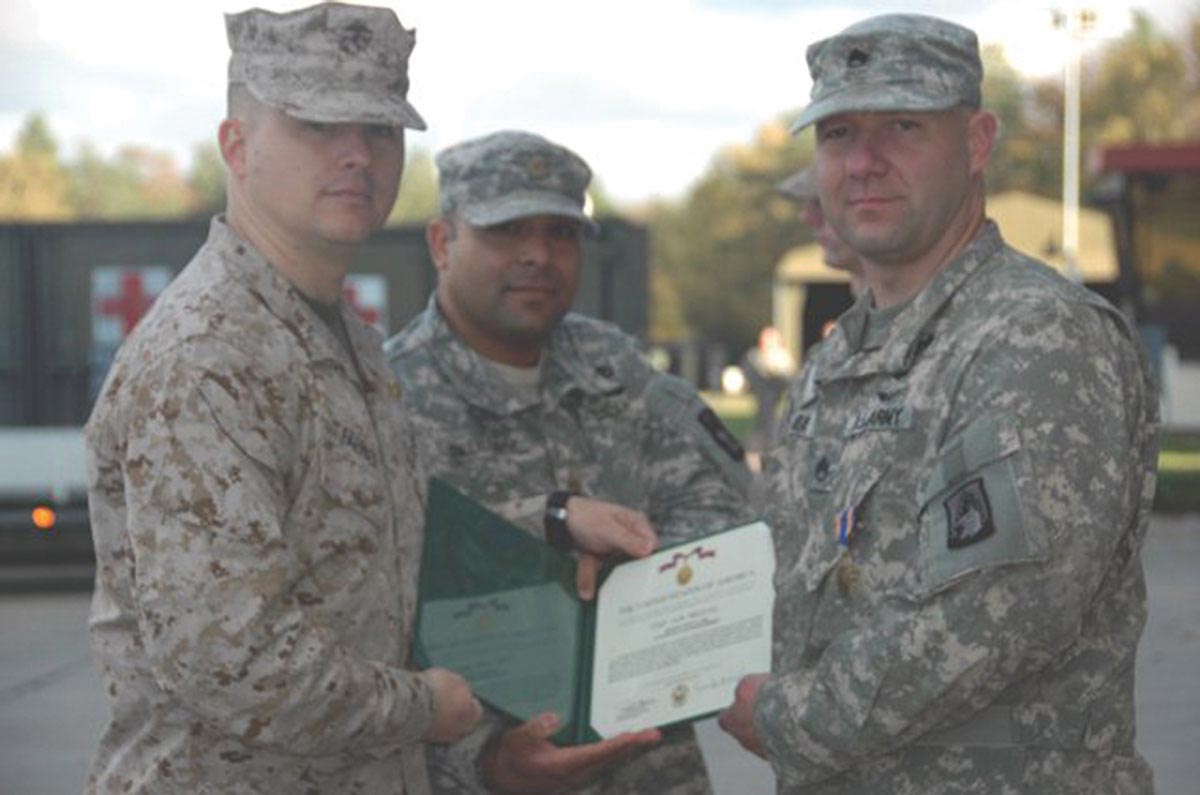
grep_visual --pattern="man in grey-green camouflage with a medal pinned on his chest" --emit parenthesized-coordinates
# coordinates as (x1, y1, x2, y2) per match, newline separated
(721, 16, 1157, 795)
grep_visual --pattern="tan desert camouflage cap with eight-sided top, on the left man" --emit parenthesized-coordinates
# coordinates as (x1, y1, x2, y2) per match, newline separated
(226, 2, 425, 130)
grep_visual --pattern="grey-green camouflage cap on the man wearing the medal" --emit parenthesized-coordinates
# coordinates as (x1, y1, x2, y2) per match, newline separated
(792, 14, 983, 132)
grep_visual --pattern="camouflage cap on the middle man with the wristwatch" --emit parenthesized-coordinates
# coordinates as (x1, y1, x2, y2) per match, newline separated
(437, 130, 596, 231)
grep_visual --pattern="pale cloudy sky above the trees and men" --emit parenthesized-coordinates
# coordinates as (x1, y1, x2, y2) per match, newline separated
(0, 0, 1200, 203)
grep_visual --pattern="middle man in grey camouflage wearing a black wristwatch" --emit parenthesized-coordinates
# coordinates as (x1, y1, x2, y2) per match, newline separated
(386, 132, 749, 795)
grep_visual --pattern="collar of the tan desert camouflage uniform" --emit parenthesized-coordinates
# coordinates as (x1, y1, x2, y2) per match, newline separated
(208, 215, 388, 383)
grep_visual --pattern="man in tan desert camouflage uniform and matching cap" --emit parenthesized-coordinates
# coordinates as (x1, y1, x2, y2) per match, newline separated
(86, 4, 480, 795)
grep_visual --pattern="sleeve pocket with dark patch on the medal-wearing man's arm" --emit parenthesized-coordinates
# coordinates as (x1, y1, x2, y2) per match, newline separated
(917, 414, 1042, 597)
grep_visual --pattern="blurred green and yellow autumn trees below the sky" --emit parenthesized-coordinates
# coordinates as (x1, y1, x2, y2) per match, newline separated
(0, 6, 1200, 351)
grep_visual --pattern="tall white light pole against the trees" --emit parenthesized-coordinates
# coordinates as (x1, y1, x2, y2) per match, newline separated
(1054, 8, 1096, 281)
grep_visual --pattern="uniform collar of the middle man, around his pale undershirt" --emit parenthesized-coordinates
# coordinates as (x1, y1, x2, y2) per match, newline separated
(416, 294, 622, 414)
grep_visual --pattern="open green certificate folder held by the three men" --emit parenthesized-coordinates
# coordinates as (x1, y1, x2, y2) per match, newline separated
(414, 478, 774, 745)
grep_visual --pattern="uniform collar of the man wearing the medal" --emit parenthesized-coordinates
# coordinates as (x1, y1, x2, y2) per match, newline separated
(822, 220, 1004, 381)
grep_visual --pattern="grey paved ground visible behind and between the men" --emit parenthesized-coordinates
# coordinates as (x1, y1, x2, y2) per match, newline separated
(0, 515, 1200, 795)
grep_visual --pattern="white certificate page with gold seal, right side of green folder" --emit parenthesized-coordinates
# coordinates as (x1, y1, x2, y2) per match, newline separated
(590, 521, 775, 737)
